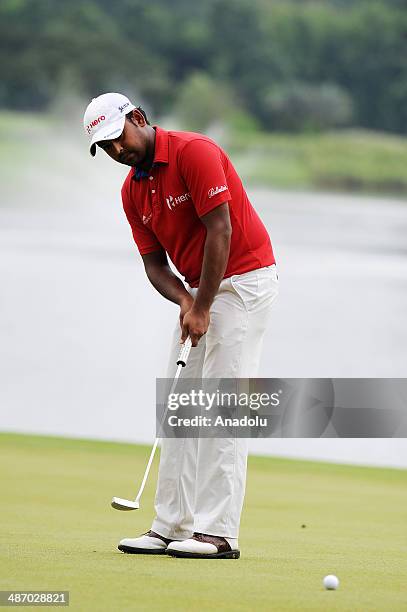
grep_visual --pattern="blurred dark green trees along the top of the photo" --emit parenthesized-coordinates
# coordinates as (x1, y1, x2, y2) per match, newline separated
(0, 0, 407, 134)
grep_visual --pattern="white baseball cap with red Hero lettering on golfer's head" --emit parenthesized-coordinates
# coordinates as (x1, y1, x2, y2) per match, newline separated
(83, 93, 136, 155)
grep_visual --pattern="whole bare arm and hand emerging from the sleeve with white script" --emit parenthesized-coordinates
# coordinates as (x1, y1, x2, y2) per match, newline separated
(181, 202, 232, 346)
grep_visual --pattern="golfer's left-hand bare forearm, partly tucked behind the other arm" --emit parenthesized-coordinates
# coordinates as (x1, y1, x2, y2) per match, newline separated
(142, 249, 194, 332)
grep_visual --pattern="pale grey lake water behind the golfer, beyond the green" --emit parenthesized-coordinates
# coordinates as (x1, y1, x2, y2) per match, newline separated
(0, 170, 407, 467)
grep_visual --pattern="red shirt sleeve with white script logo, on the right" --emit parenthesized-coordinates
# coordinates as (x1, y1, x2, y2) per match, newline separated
(178, 138, 232, 217)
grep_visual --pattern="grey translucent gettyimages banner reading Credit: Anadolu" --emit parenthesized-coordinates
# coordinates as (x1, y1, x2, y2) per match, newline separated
(156, 378, 407, 438)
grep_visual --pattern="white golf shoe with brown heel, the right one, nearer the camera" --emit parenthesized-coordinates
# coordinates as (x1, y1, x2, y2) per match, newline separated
(166, 533, 240, 559)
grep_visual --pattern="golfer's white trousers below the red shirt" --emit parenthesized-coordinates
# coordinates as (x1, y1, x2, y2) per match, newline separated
(151, 266, 278, 540)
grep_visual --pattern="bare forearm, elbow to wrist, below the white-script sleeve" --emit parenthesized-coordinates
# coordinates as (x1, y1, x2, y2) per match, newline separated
(193, 230, 231, 310)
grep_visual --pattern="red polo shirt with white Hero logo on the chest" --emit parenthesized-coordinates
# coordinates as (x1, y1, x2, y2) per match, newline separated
(122, 127, 275, 287)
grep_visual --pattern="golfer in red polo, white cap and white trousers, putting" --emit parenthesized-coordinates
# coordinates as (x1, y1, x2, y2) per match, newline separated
(84, 93, 278, 558)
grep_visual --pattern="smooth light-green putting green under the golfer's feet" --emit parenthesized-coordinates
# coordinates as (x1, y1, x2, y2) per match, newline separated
(0, 434, 407, 612)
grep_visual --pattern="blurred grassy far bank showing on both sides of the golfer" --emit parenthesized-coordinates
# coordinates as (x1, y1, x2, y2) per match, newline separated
(0, 111, 407, 204)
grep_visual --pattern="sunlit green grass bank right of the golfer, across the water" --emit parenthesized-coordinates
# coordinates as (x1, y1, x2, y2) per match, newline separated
(229, 130, 407, 196)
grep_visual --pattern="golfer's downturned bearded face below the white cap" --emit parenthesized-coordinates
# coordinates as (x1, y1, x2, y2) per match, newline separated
(97, 109, 150, 166)
